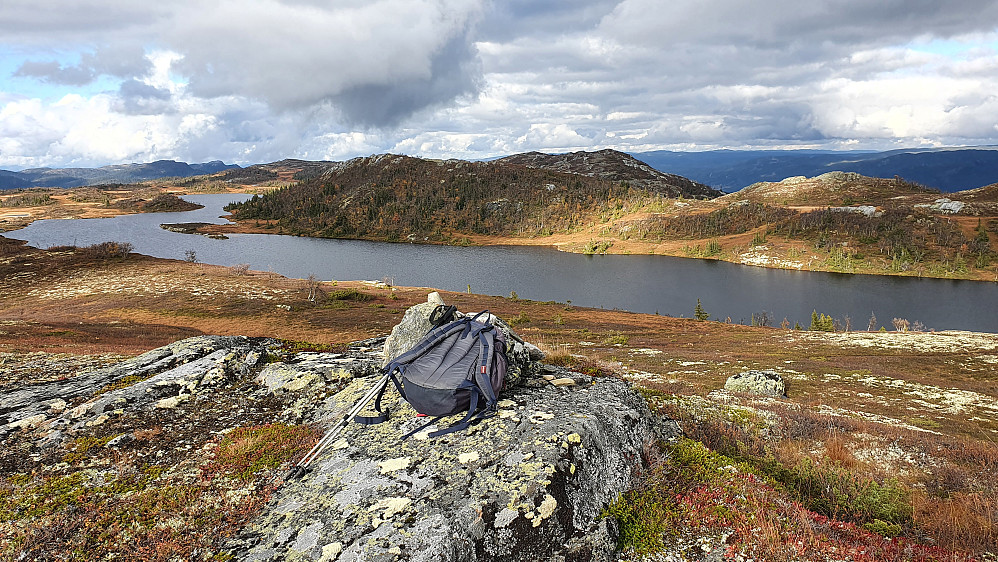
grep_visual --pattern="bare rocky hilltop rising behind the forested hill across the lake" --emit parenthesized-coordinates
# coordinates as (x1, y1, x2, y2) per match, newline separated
(499, 149, 724, 199)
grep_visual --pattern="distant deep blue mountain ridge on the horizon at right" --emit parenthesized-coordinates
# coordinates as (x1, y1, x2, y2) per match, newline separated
(633, 147, 998, 193)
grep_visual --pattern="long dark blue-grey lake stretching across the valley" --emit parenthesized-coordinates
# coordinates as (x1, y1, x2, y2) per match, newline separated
(4, 194, 998, 332)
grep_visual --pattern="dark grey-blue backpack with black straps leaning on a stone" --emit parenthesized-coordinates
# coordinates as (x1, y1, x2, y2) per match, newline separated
(354, 311, 508, 439)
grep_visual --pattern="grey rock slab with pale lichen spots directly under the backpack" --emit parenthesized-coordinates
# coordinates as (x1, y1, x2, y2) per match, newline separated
(228, 370, 678, 562)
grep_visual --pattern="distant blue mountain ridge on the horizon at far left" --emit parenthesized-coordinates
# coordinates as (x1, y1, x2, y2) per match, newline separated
(0, 160, 239, 189)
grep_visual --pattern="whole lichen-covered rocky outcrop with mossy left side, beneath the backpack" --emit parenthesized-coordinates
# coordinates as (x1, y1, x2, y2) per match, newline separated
(0, 301, 678, 561)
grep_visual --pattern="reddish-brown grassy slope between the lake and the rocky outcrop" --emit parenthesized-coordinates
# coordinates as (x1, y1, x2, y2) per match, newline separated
(0, 241, 998, 560)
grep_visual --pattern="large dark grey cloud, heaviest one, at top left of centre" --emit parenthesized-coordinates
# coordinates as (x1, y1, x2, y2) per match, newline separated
(168, 0, 481, 127)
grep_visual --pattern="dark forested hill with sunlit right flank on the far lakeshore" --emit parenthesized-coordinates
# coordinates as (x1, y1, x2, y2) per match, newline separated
(227, 154, 704, 242)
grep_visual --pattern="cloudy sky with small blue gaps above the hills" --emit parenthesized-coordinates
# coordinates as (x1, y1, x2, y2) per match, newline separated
(0, 0, 998, 169)
